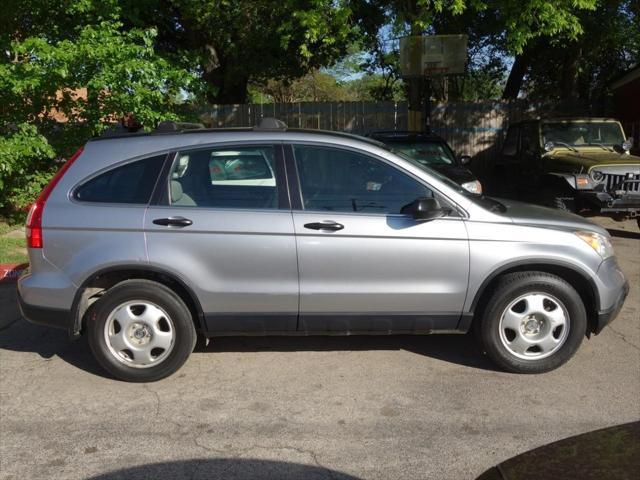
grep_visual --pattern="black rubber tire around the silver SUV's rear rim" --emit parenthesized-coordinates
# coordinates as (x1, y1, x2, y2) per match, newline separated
(87, 280, 196, 382)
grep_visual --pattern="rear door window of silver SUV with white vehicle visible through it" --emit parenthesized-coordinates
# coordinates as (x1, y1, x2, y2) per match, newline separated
(170, 146, 278, 209)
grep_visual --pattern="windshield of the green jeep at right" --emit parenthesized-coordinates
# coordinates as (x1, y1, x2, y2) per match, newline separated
(542, 122, 624, 147)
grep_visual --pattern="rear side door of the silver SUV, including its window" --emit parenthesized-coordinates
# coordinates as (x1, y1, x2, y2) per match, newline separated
(145, 144, 298, 334)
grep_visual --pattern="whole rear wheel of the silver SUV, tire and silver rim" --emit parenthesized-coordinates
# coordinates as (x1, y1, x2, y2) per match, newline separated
(87, 280, 196, 382)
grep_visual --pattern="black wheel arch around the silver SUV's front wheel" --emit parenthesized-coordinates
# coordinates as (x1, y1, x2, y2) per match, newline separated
(459, 259, 600, 336)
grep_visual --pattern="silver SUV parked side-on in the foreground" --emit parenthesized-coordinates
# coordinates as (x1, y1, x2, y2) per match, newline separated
(18, 121, 629, 381)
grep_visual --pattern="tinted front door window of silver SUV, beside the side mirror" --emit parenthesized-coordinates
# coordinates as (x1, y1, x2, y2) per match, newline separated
(294, 146, 433, 213)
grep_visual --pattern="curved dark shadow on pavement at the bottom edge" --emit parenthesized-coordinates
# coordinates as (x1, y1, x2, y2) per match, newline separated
(87, 458, 358, 480)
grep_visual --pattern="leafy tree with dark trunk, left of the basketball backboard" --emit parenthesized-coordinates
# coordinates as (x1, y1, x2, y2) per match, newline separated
(126, 0, 355, 103)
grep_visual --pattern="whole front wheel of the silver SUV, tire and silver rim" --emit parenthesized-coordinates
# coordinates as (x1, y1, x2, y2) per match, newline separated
(478, 272, 587, 373)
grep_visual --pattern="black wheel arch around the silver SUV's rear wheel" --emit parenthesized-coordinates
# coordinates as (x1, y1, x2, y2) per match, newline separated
(69, 264, 205, 337)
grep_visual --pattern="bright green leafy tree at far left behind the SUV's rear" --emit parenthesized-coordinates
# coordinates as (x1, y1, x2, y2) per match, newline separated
(0, 0, 195, 214)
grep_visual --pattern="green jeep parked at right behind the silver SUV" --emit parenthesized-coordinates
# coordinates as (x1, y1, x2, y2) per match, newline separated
(493, 117, 640, 226)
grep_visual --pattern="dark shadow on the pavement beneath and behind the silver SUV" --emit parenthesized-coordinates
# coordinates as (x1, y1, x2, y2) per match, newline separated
(0, 319, 496, 378)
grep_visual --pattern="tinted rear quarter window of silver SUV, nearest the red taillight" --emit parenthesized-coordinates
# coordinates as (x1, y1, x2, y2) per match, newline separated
(74, 155, 166, 205)
